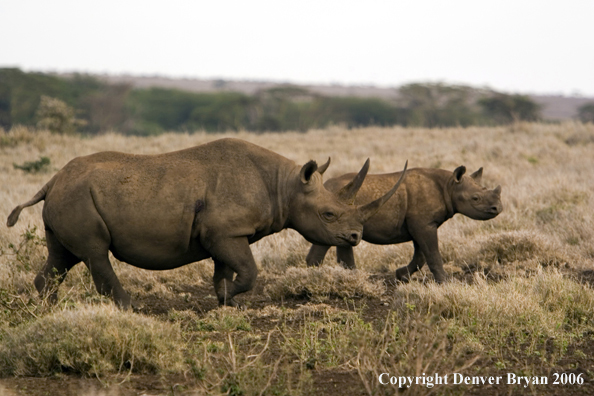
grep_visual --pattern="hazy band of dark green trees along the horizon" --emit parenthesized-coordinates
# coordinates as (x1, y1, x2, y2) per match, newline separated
(0, 68, 540, 135)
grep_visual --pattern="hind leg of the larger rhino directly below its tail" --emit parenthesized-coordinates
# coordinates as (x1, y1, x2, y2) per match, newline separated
(34, 228, 81, 303)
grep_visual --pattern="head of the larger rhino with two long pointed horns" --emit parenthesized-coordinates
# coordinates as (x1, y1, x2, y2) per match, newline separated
(289, 159, 406, 246)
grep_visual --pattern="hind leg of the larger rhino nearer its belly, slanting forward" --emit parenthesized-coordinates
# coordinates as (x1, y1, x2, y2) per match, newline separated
(85, 252, 132, 310)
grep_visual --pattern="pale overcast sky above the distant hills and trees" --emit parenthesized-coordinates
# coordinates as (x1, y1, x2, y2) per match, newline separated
(0, 0, 594, 96)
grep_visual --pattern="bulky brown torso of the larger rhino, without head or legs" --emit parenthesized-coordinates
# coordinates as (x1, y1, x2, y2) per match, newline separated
(44, 139, 294, 269)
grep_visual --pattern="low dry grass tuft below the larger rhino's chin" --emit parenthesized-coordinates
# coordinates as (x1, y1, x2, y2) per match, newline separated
(264, 265, 386, 301)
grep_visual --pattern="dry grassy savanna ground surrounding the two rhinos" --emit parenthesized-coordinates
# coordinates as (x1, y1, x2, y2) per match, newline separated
(0, 123, 594, 395)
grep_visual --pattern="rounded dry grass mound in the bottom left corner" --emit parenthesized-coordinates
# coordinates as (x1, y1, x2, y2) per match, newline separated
(0, 305, 184, 376)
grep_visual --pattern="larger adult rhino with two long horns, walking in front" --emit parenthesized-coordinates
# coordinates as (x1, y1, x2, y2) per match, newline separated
(7, 139, 402, 308)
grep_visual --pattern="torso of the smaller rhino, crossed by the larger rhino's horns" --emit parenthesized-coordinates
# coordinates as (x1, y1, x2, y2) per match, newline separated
(325, 168, 451, 244)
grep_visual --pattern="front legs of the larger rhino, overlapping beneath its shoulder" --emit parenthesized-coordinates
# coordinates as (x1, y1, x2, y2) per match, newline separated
(210, 237, 258, 308)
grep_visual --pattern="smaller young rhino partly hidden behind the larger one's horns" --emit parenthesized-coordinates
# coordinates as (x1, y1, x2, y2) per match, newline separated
(306, 166, 503, 283)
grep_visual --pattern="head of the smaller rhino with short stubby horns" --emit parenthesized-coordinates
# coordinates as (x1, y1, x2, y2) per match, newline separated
(451, 166, 503, 220)
